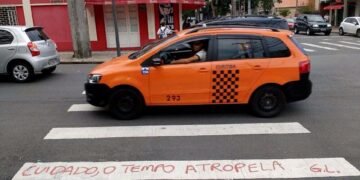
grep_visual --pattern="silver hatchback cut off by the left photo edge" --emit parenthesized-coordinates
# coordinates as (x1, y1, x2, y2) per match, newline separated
(0, 26, 60, 82)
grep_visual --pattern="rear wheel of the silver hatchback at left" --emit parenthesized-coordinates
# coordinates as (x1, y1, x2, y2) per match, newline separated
(8, 61, 35, 83)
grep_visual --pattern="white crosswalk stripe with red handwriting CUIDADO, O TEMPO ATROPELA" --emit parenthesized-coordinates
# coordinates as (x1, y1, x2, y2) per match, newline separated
(13, 158, 360, 180)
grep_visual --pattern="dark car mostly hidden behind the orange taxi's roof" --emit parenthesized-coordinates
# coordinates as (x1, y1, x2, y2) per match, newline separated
(196, 16, 289, 30)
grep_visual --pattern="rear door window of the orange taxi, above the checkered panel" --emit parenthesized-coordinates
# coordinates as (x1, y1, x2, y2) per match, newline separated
(218, 38, 265, 60)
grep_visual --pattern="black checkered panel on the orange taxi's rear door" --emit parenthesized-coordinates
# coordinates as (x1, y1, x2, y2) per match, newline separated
(211, 70, 240, 104)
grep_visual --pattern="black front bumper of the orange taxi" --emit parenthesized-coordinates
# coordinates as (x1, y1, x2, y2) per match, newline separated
(85, 83, 110, 107)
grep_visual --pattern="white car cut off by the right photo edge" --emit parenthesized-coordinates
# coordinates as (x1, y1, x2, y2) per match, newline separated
(339, 17, 360, 37)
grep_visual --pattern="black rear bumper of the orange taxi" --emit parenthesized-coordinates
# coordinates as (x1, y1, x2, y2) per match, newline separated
(285, 74, 312, 102)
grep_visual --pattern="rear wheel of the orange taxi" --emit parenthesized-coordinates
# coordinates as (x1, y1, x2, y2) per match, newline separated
(250, 85, 286, 118)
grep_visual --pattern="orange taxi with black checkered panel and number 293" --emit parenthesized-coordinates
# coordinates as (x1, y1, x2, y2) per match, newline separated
(85, 27, 312, 119)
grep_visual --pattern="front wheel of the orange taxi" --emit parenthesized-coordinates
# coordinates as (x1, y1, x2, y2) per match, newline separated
(109, 88, 145, 120)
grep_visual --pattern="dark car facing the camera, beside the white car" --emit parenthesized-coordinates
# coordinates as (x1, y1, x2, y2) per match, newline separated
(294, 14, 332, 36)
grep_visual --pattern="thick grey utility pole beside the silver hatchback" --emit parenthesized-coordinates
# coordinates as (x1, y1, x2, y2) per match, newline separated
(67, 0, 91, 58)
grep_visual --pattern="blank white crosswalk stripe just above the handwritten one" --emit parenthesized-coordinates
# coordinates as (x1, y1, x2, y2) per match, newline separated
(44, 122, 310, 139)
